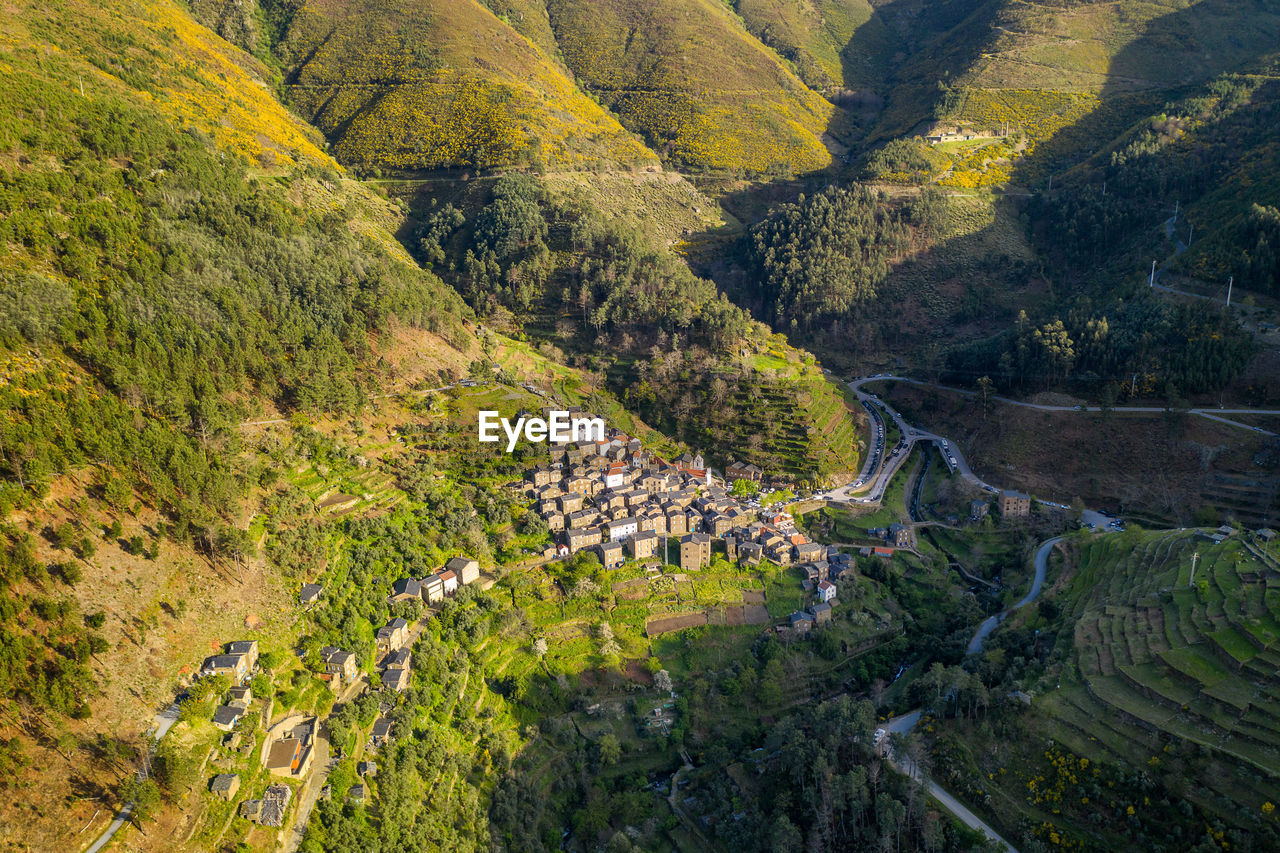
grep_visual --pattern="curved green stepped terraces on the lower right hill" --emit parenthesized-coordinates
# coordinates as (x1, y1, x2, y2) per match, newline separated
(1037, 530, 1280, 807)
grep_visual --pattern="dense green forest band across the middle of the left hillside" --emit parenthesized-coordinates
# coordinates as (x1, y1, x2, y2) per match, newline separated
(0, 63, 466, 523)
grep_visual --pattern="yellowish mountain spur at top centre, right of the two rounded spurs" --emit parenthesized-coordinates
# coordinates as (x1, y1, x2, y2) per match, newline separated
(547, 0, 835, 173)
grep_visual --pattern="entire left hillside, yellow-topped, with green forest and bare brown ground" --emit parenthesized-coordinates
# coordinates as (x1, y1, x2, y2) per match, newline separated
(0, 4, 483, 835)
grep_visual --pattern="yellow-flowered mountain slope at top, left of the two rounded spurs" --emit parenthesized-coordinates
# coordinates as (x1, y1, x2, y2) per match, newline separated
(266, 0, 657, 170)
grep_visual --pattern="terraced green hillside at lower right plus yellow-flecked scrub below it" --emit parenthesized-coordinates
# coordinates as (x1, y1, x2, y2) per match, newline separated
(952, 530, 1280, 849)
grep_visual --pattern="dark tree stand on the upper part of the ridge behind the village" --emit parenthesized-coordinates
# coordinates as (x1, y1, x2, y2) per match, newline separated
(417, 175, 750, 352)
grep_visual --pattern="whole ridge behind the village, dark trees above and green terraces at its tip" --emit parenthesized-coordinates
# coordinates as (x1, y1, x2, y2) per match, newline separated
(401, 175, 858, 482)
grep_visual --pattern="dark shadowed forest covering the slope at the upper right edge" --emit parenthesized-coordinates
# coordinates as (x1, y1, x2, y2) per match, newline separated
(1028, 74, 1280, 293)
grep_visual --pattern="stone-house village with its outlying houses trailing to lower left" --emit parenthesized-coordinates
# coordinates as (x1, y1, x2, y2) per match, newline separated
(180, 399, 914, 834)
